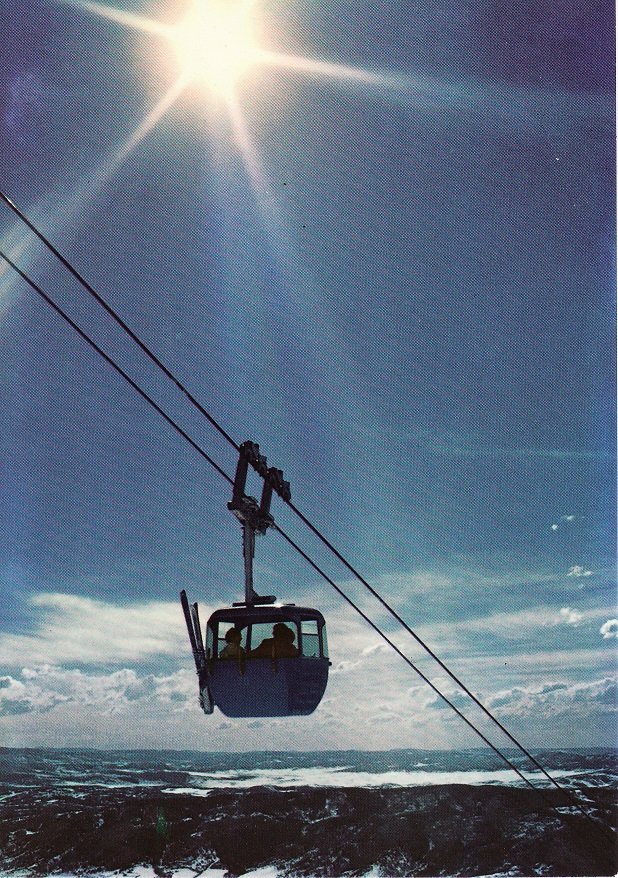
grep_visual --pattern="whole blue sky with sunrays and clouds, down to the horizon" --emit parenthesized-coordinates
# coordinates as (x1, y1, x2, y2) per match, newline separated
(0, 0, 618, 750)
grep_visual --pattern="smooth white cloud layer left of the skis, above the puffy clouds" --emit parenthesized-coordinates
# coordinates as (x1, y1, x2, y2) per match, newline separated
(0, 593, 202, 667)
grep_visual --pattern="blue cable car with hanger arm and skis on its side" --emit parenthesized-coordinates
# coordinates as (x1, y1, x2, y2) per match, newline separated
(180, 442, 330, 717)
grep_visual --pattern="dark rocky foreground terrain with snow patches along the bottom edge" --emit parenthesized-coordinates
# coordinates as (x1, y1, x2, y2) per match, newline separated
(0, 785, 618, 876)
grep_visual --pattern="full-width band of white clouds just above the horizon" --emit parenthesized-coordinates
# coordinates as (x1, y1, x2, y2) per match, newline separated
(0, 577, 618, 750)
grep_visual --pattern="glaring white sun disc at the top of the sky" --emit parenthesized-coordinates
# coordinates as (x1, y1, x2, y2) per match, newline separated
(170, 0, 259, 95)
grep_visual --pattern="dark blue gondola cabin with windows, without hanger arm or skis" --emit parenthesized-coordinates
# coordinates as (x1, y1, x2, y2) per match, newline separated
(205, 605, 330, 717)
